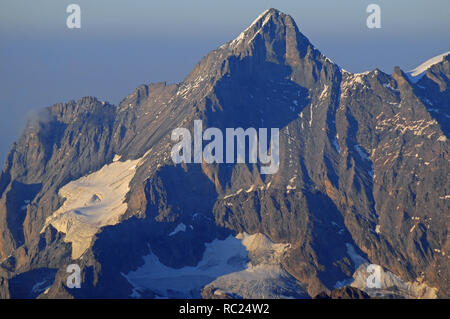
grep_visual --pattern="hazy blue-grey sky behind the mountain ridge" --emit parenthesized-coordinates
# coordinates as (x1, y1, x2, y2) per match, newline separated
(0, 0, 450, 163)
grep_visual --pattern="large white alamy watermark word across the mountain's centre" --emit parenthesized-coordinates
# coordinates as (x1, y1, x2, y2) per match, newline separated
(171, 120, 280, 174)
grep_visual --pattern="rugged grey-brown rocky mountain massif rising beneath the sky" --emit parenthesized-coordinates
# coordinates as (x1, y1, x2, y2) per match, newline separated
(0, 9, 450, 298)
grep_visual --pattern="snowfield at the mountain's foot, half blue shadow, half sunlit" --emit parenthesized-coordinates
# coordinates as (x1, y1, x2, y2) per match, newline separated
(122, 233, 303, 298)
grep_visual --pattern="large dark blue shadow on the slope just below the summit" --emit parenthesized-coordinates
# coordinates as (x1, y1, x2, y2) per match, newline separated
(204, 56, 310, 189)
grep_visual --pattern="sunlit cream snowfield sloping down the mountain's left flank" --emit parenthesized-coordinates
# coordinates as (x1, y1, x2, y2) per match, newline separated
(41, 157, 140, 259)
